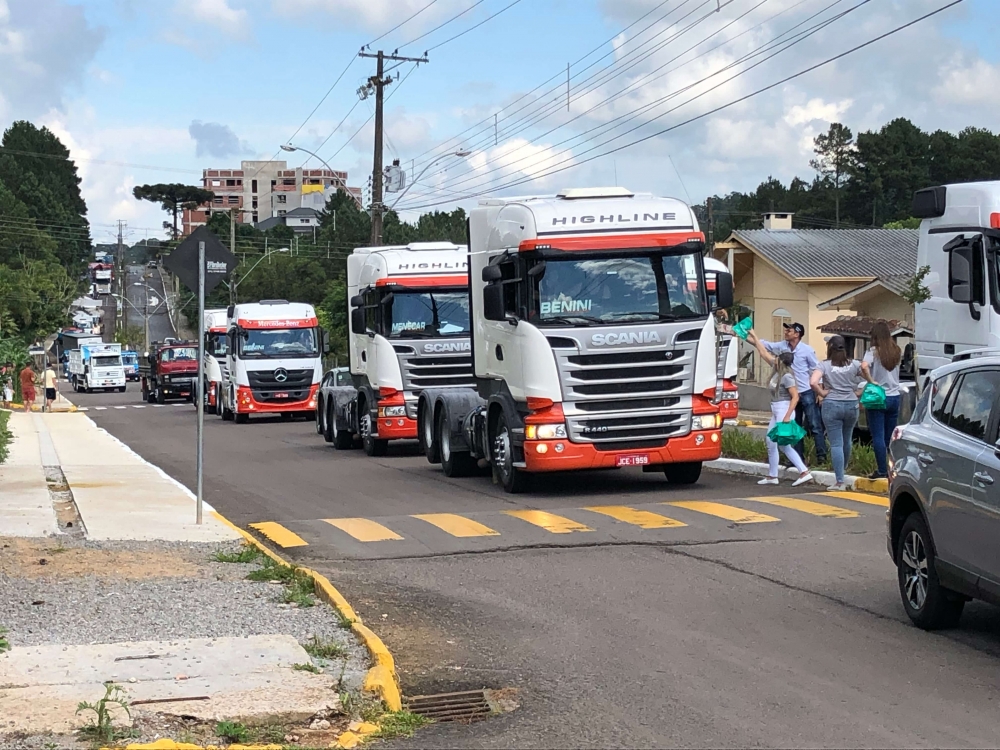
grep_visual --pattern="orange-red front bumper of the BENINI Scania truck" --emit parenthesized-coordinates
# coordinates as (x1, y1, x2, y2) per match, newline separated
(524, 430, 722, 472)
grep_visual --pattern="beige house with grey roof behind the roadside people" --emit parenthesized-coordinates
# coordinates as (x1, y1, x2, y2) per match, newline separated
(713, 213, 918, 382)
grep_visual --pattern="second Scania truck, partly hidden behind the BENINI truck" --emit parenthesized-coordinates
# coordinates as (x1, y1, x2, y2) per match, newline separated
(322, 242, 472, 456)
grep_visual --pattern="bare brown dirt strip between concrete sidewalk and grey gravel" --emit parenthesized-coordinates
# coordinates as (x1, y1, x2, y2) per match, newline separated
(0, 538, 206, 579)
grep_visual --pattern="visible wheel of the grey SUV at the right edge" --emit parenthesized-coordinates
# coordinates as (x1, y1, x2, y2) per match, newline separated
(896, 513, 965, 630)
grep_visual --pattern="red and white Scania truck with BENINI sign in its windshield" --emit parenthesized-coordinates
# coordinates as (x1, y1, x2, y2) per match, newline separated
(417, 188, 733, 492)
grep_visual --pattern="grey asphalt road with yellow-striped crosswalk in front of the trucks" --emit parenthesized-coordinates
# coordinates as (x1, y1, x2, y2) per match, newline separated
(66, 385, 1000, 748)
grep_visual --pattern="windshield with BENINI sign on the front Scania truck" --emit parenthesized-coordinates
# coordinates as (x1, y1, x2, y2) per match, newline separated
(528, 250, 708, 325)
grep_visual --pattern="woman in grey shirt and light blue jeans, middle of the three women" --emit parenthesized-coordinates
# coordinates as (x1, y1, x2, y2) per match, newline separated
(809, 336, 872, 490)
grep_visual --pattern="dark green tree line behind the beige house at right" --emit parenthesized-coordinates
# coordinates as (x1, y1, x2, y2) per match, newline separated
(695, 118, 1000, 241)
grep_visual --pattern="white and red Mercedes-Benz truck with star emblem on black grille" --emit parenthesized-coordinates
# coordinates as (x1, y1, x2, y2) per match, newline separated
(218, 300, 327, 423)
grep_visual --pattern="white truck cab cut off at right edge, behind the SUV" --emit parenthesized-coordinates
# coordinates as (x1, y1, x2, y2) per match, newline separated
(913, 181, 1000, 383)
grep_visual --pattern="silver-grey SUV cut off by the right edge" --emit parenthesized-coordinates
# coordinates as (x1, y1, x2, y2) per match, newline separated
(886, 356, 1000, 630)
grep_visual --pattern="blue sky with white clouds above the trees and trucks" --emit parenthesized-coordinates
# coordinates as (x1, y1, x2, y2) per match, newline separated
(0, 0, 1000, 247)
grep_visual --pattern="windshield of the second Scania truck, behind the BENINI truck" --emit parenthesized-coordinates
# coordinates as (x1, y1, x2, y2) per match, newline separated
(383, 289, 469, 339)
